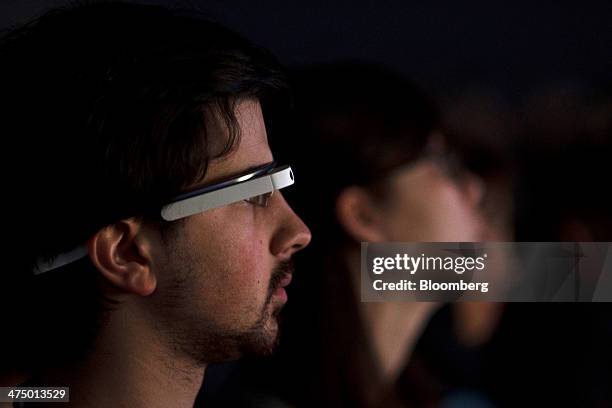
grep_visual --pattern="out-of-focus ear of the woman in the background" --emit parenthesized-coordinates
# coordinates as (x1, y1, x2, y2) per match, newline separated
(336, 186, 384, 242)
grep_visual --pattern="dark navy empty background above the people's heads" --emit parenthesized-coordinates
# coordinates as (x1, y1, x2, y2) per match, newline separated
(0, 0, 612, 104)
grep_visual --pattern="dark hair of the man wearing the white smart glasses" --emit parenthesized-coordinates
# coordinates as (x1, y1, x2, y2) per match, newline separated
(0, 2, 287, 370)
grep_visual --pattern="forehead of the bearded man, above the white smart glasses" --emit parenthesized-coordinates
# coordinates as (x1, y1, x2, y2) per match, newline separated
(204, 99, 273, 183)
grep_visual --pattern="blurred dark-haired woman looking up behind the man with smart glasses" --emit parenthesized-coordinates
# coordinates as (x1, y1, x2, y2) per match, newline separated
(258, 64, 484, 407)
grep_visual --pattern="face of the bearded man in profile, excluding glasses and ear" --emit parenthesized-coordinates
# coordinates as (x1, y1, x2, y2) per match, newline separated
(146, 100, 310, 363)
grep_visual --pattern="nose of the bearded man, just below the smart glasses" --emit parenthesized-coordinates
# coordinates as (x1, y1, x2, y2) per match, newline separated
(270, 194, 312, 259)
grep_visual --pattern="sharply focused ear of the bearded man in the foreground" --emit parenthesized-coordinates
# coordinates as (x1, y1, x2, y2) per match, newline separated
(87, 218, 157, 296)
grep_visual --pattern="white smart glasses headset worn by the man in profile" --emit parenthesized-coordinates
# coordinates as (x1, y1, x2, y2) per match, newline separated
(34, 162, 295, 275)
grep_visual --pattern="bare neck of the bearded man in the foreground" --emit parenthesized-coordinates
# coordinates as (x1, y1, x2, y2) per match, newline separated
(34, 311, 205, 408)
